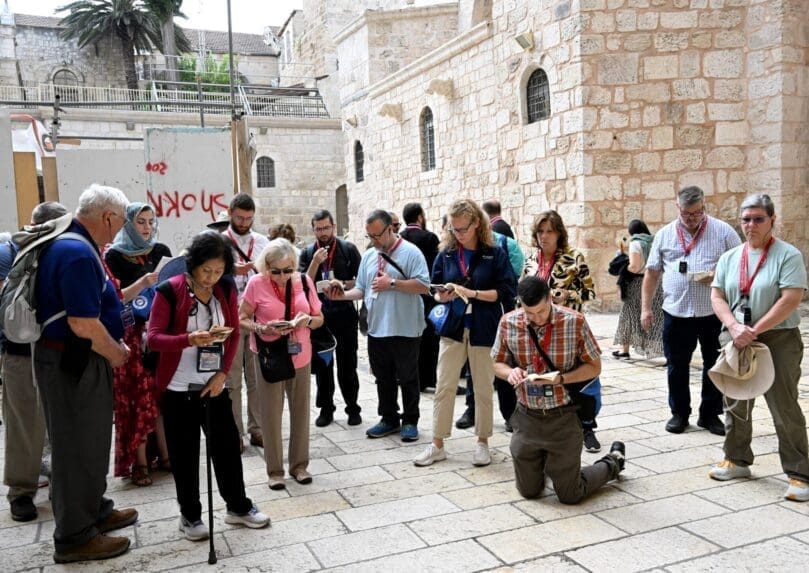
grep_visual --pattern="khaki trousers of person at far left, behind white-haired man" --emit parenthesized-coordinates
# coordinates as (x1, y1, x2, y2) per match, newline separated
(3, 354, 45, 501)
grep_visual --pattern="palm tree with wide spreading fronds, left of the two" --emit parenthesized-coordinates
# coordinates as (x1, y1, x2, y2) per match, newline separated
(56, 0, 163, 90)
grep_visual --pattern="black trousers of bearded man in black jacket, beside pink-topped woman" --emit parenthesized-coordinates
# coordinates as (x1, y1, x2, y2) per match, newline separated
(312, 313, 362, 416)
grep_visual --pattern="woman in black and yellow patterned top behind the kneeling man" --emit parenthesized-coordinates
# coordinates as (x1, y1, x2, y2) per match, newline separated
(520, 210, 601, 452)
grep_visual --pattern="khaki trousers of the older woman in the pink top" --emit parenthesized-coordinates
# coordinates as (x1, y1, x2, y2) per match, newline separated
(258, 362, 312, 478)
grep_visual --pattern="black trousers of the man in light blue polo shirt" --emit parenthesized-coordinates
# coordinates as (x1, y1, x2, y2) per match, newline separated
(368, 336, 421, 425)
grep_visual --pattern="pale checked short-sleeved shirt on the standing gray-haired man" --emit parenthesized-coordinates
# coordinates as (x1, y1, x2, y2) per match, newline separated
(646, 215, 741, 318)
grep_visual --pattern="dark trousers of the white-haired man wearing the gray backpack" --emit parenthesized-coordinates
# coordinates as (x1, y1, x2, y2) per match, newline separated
(34, 344, 113, 552)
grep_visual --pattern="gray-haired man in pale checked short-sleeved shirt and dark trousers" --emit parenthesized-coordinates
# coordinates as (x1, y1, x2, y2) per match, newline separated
(641, 186, 741, 436)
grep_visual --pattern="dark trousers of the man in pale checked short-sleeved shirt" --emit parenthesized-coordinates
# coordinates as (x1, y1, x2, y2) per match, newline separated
(663, 311, 722, 418)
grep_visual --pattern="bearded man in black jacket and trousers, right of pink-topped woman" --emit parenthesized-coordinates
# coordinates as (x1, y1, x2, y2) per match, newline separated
(298, 209, 362, 428)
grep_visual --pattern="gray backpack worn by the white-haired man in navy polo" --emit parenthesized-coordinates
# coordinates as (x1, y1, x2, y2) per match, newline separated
(0, 213, 107, 344)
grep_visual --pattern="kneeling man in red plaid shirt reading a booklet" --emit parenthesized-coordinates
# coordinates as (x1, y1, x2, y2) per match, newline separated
(492, 276, 625, 504)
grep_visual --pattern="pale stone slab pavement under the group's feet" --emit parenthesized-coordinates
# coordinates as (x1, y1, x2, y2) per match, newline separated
(0, 314, 809, 572)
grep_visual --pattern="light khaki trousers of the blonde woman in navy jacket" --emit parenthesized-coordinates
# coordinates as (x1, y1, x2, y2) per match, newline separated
(433, 328, 494, 440)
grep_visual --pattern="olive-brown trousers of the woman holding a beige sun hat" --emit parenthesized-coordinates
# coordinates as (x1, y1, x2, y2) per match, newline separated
(725, 328, 809, 482)
